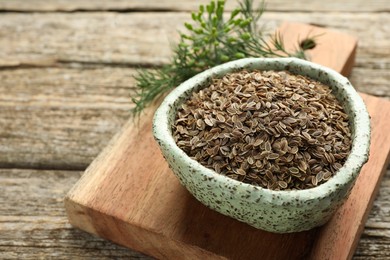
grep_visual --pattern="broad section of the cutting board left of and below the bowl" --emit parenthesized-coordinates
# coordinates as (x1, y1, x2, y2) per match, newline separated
(65, 108, 313, 259)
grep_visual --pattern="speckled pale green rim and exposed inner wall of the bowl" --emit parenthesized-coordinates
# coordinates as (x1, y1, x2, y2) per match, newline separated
(154, 58, 370, 203)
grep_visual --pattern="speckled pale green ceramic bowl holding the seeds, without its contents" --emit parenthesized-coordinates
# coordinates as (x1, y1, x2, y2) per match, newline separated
(153, 58, 370, 233)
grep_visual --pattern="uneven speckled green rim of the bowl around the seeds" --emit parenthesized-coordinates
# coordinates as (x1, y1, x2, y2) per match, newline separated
(153, 58, 371, 206)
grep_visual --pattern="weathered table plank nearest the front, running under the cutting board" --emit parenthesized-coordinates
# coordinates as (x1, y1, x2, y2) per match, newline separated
(0, 169, 390, 260)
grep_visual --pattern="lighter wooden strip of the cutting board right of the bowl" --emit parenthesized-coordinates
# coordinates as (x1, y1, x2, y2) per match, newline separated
(311, 95, 390, 259)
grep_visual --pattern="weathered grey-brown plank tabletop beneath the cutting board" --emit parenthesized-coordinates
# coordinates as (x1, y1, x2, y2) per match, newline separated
(0, 0, 390, 259)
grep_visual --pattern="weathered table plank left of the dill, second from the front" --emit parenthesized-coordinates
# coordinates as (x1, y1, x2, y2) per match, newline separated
(0, 68, 134, 170)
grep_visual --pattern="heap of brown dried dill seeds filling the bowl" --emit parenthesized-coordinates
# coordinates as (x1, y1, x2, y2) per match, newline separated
(172, 71, 352, 190)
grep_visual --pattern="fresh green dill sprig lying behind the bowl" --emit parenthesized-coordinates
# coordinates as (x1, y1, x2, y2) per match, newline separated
(132, 0, 316, 115)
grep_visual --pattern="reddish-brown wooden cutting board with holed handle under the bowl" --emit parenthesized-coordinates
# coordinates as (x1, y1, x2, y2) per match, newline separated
(65, 24, 390, 259)
